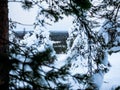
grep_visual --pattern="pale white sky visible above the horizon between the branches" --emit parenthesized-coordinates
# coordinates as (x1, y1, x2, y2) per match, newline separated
(9, 2, 72, 30)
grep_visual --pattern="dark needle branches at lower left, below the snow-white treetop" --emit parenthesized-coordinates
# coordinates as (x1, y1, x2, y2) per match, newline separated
(9, 40, 55, 90)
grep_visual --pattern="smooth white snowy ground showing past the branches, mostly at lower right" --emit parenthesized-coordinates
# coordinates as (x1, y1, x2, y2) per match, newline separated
(58, 53, 120, 90)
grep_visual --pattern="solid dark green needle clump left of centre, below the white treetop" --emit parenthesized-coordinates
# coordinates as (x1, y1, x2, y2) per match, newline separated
(30, 49, 55, 78)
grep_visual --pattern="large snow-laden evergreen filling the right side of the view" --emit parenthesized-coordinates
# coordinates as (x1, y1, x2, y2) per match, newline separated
(41, 0, 120, 90)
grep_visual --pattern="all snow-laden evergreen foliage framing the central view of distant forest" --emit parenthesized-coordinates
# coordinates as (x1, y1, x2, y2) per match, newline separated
(7, 0, 120, 90)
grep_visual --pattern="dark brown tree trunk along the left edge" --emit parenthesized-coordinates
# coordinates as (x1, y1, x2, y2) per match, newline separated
(0, 0, 9, 90)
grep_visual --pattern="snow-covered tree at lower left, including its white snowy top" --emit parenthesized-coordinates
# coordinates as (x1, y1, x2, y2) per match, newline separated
(9, 27, 56, 90)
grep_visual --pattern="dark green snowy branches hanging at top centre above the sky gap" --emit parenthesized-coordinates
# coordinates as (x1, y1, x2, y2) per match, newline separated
(37, 0, 92, 25)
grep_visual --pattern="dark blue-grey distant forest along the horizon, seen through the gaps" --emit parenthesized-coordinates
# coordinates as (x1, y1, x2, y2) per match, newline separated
(14, 31, 68, 54)
